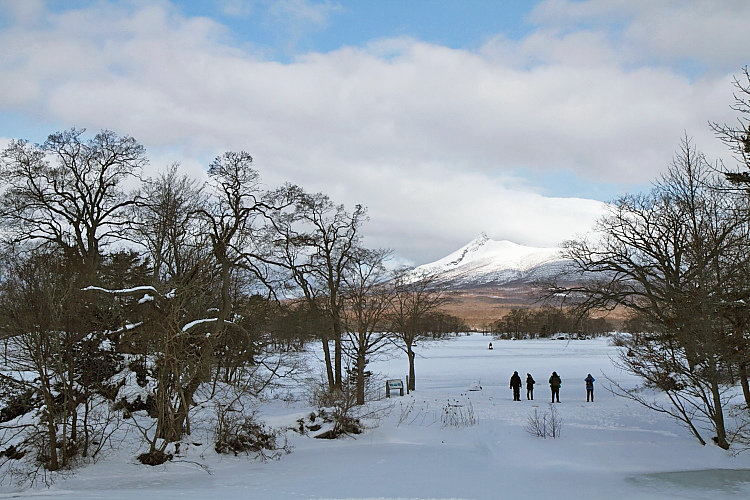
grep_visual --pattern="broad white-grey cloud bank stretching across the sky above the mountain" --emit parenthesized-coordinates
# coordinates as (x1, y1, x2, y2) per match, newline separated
(0, 0, 748, 263)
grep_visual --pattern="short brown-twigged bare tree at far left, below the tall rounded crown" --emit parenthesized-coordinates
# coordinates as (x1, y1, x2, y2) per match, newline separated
(0, 250, 125, 471)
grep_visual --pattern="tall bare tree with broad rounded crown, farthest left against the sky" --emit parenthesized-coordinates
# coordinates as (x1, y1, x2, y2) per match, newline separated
(0, 129, 146, 469)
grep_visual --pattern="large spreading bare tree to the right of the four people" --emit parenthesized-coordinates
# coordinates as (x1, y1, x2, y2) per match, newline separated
(550, 139, 746, 448)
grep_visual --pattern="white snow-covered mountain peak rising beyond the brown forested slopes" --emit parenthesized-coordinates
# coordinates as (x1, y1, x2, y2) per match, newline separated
(416, 233, 566, 288)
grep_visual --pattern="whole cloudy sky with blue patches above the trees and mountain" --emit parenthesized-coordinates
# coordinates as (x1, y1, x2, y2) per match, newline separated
(0, 0, 750, 265)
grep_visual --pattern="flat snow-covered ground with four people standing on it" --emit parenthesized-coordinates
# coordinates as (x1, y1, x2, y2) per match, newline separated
(0, 335, 750, 500)
